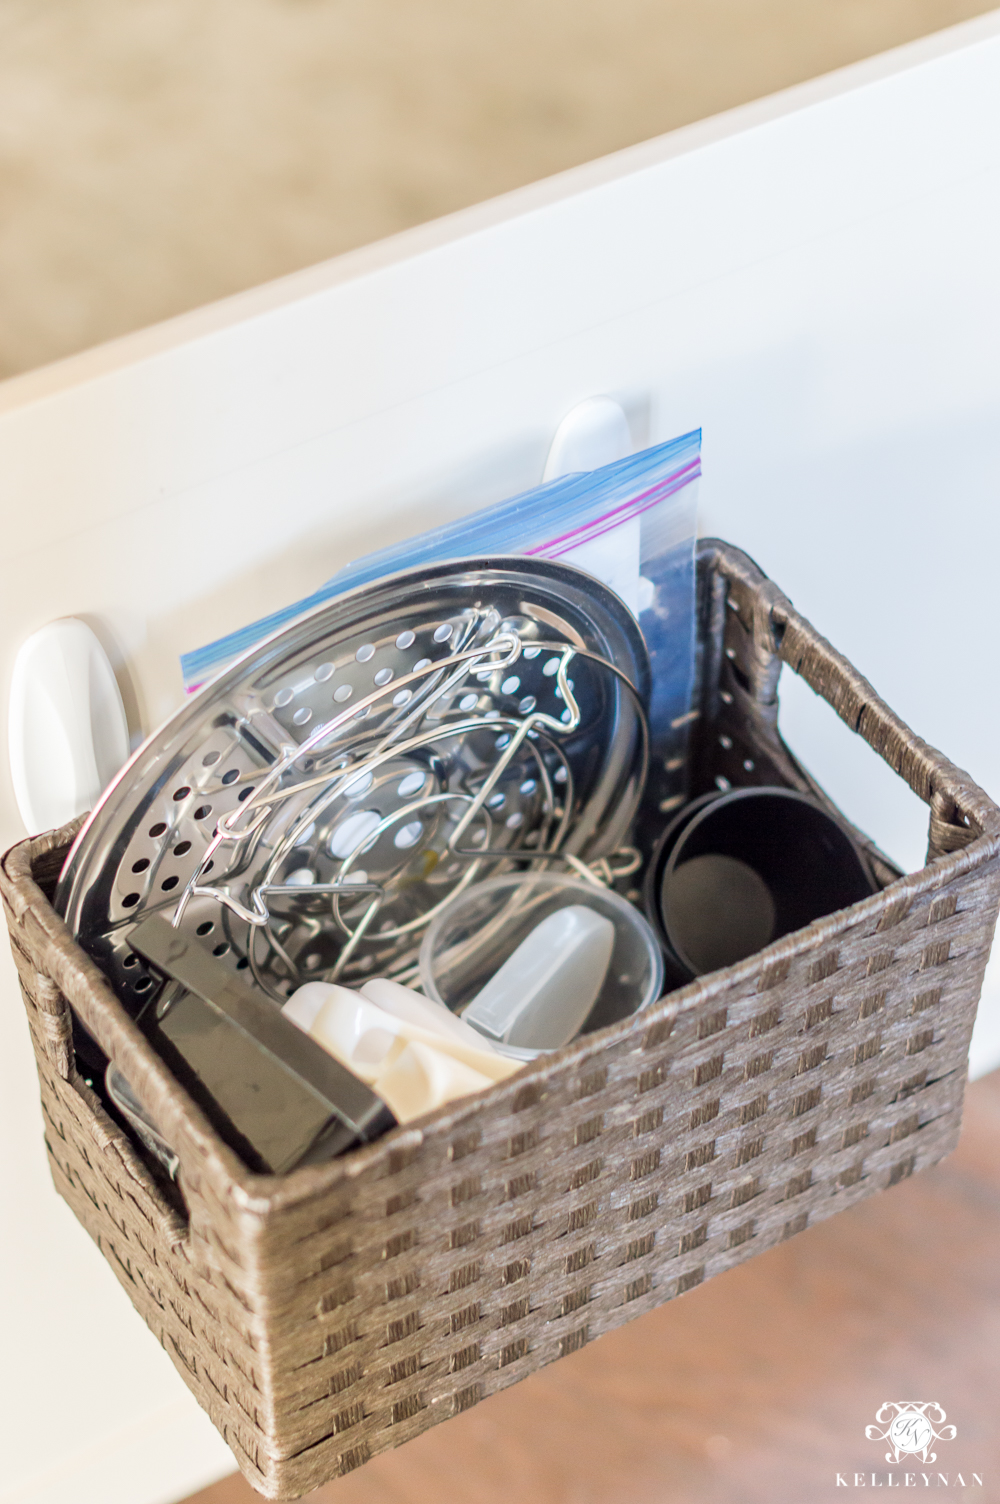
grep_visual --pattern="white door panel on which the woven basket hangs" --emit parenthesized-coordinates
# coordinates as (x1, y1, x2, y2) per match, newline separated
(0, 14, 1000, 1504)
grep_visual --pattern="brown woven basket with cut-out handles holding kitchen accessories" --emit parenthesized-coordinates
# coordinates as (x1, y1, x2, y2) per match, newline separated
(7, 541, 1000, 1496)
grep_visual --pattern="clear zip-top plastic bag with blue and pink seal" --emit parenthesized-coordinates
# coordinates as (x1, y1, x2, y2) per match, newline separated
(180, 429, 701, 808)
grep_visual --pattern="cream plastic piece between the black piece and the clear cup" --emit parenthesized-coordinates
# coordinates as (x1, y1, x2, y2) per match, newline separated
(283, 982, 520, 1122)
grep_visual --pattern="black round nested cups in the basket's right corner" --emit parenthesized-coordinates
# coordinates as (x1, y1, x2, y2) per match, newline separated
(645, 788, 877, 985)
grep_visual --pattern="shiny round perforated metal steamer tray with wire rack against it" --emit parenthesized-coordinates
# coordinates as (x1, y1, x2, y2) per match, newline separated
(56, 558, 650, 1012)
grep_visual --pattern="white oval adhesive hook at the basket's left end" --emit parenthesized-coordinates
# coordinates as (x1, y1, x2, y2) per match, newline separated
(9, 617, 129, 835)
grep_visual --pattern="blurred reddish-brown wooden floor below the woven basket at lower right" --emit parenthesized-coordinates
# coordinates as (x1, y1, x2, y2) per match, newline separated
(189, 1072, 1000, 1504)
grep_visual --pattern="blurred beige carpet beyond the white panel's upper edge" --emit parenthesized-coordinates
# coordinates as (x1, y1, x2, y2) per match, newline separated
(0, 0, 989, 376)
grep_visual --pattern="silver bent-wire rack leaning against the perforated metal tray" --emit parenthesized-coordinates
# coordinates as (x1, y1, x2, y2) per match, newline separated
(171, 630, 650, 997)
